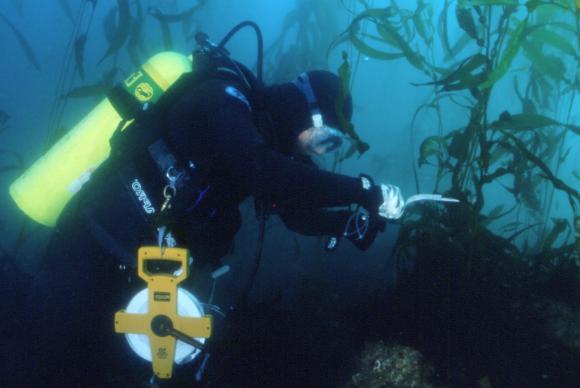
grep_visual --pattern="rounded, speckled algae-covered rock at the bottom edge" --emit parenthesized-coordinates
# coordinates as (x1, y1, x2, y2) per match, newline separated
(346, 341, 434, 388)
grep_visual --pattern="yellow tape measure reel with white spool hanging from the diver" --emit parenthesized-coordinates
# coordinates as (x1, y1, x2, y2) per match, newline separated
(115, 247, 212, 379)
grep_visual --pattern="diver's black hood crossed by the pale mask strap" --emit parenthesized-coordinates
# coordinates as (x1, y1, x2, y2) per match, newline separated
(262, 71, 352, 154)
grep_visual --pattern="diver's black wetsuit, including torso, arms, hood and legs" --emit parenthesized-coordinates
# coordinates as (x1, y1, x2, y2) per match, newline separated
(8, 76, 381, 386)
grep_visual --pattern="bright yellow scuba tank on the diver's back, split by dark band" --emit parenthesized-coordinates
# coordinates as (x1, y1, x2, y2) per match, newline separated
(10, 52, 192, 227)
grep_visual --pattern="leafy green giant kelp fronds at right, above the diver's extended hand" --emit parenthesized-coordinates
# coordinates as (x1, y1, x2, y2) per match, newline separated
(345, 0, 580, 260)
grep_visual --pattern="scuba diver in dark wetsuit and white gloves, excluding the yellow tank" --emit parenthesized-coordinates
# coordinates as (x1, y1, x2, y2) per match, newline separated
(3, 22, 412, 386)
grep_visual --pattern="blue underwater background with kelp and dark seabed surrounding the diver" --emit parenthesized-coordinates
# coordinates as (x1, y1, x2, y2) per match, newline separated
(0, 0, 580, 387)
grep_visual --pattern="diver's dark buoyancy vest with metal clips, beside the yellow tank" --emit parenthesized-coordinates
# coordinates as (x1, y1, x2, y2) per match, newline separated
(71, 22, 267, 265)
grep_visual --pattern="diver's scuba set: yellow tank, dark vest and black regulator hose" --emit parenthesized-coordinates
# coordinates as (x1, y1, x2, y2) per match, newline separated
(10, 22, 272, 270)
